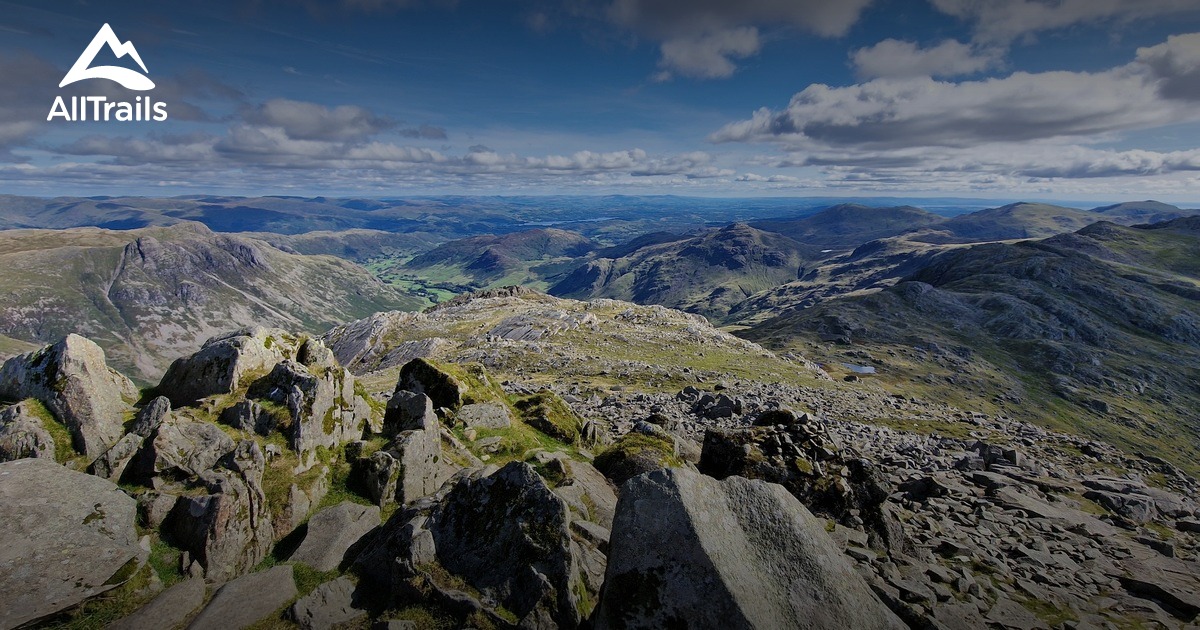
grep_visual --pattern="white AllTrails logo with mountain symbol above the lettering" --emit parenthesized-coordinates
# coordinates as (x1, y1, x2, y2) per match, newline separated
(46, 24, 167, 122)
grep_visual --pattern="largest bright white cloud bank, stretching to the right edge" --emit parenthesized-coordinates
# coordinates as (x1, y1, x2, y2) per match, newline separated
(710, 37, 1200, 149)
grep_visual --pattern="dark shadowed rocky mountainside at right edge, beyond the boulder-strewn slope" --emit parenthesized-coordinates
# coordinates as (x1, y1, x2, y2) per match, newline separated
(744, 217, 1200, 461)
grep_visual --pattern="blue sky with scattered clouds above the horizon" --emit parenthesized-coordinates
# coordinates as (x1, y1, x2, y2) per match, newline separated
(0, 0, 1200, 203)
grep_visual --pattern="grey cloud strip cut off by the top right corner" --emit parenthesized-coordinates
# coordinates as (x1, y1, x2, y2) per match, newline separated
(930, 0, 1200, 43)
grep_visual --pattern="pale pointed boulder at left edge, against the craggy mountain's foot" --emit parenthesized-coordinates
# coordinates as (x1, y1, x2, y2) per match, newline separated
(0, 335, 138, 458)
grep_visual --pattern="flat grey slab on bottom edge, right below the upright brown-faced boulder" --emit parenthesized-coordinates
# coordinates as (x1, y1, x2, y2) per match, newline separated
(188, 565, 296, 630)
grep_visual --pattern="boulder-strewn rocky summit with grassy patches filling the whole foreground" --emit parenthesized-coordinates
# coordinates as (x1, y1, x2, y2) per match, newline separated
(0, 288, 1200, 630)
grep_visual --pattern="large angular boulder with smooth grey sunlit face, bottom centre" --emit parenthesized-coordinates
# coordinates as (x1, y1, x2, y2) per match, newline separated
(593, 469, 906, 630)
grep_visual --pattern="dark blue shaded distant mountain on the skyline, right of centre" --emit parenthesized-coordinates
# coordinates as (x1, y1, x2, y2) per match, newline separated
(750, 204, 946, 248)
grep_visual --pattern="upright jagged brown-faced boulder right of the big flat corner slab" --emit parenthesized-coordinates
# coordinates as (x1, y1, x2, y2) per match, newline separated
(163, 440, 275, 582)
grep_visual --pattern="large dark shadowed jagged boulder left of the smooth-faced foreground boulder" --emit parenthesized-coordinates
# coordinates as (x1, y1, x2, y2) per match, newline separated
(356, 462, 582, 629)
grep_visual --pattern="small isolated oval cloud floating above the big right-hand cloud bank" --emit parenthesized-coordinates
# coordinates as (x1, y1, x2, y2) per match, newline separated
(851, 40, 1000, 79)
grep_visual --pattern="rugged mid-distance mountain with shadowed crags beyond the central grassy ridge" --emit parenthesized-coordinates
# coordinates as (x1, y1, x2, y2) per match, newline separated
(548, 223, 817, 319)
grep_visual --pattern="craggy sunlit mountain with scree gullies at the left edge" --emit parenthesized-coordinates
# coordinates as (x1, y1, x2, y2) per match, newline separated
(0, 223, 421, 379)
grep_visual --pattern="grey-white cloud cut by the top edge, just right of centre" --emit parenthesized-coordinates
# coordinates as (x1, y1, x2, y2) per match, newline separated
(607, 0, 871, 80)
